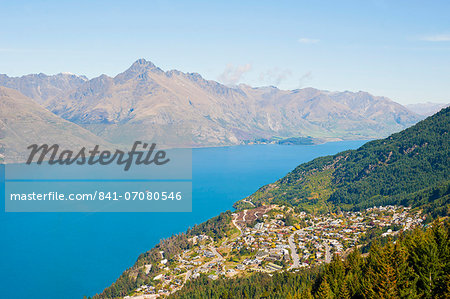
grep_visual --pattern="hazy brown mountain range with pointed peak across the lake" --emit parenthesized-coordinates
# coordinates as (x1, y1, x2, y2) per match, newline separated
(0, 59, 423, 147)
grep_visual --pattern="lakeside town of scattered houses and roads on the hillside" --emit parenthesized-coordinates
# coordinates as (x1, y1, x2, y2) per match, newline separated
(125, 205, 425, 299)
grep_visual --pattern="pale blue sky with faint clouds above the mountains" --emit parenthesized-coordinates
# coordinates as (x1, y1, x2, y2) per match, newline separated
(0, 0, 450, 104)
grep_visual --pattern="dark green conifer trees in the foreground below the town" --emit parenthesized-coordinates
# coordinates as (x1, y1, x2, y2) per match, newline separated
(169, 221, 450, 299)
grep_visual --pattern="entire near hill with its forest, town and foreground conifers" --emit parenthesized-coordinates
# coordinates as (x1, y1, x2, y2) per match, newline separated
(90, 108, 450, 298)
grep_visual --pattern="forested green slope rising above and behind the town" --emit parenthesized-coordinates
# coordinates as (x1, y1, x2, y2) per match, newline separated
(235, 108, 450, 215)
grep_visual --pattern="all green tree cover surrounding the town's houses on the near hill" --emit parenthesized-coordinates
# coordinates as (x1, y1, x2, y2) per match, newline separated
(94, 108, 450, 298)
